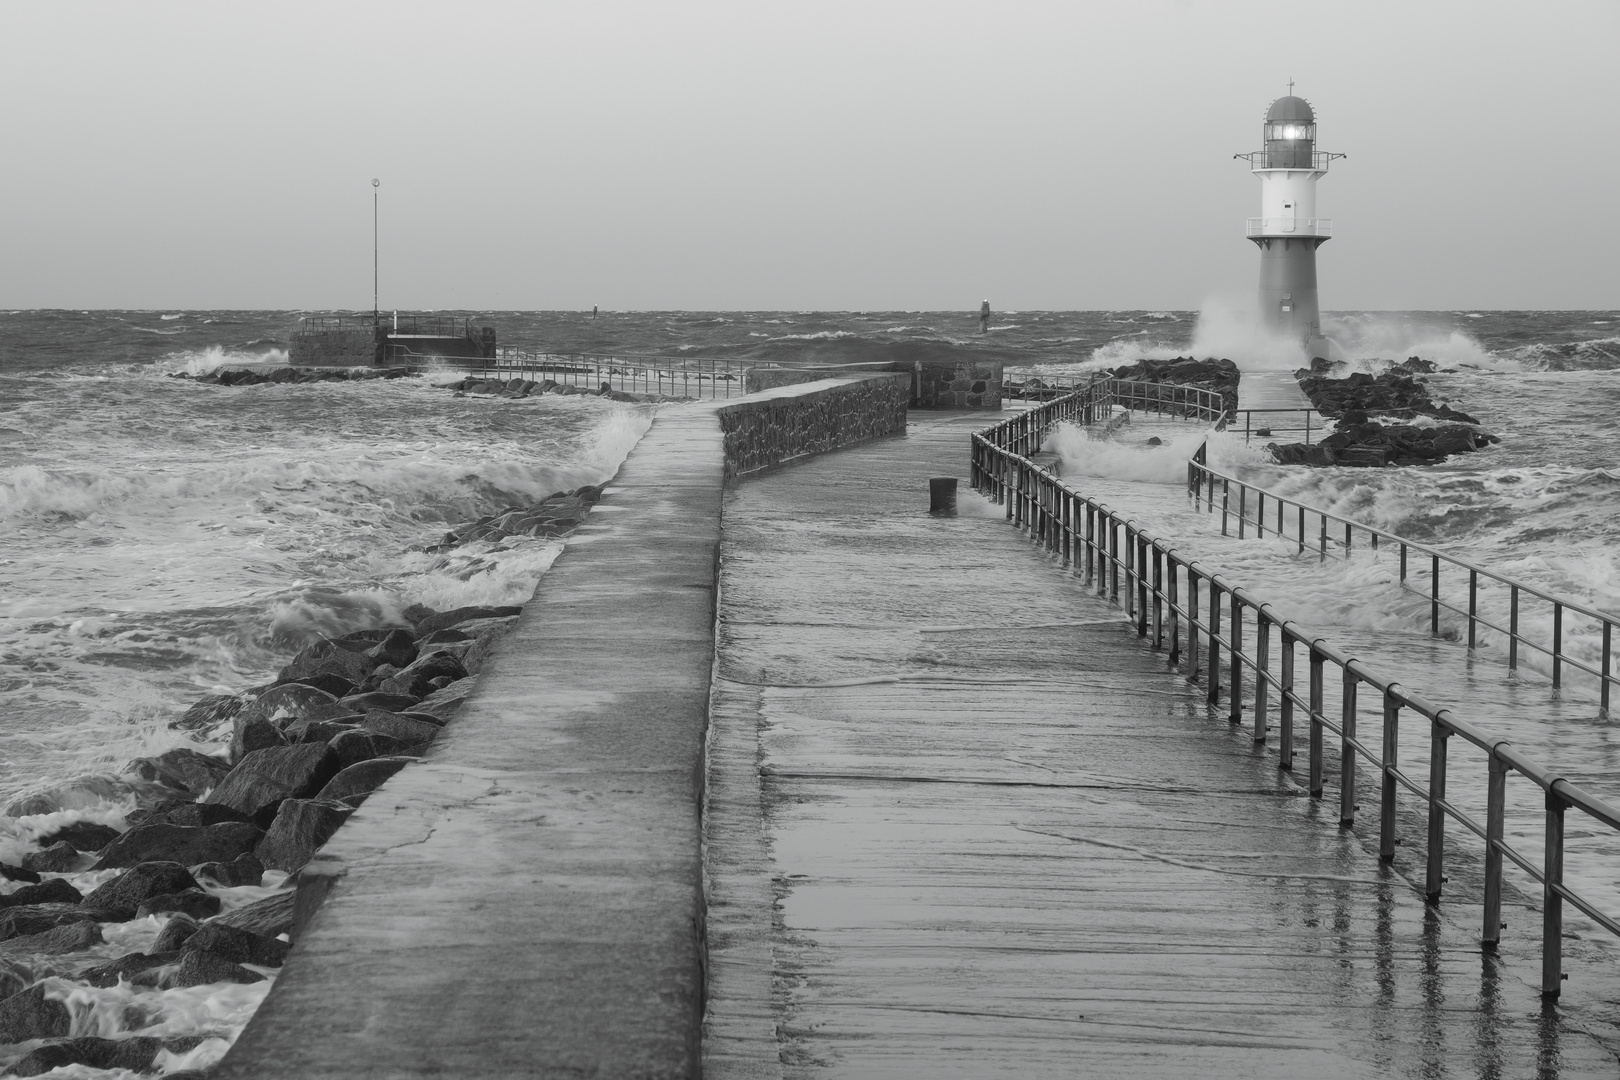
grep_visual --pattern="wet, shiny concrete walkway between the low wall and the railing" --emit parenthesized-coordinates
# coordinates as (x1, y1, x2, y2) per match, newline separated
(703, 413, 1615, 1080)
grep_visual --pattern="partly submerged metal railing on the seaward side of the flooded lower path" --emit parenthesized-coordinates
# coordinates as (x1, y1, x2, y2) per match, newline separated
(1187, 444, 1620, 717)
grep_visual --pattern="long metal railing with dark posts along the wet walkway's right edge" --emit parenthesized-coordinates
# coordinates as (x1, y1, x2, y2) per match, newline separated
(970, 384, 1620, 997)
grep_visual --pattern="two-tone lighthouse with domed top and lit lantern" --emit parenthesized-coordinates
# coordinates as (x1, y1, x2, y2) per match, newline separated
(1238, 83, 1345, 356)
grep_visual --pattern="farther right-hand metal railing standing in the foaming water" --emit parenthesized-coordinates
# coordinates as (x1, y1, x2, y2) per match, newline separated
(1187, 455, 1620, 716)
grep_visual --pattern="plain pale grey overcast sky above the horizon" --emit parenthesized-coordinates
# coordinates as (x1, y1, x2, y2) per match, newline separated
(0, 0, 1620, 309)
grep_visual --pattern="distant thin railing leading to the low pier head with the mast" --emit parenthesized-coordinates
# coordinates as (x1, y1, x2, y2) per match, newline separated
(411, 345, 758, 398)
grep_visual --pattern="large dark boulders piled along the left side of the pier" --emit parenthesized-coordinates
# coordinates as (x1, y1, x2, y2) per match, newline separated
(0, 486, 601, 1075)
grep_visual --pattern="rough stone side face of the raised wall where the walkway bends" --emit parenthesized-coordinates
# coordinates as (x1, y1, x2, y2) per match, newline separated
(719, 374, 912, 479)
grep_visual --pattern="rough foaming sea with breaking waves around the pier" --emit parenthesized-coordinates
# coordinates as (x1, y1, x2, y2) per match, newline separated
(0, 309, 1620, 1064)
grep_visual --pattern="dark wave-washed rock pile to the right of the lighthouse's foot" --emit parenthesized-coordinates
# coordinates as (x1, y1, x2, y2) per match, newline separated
(1267, 356, 1499, 466)
